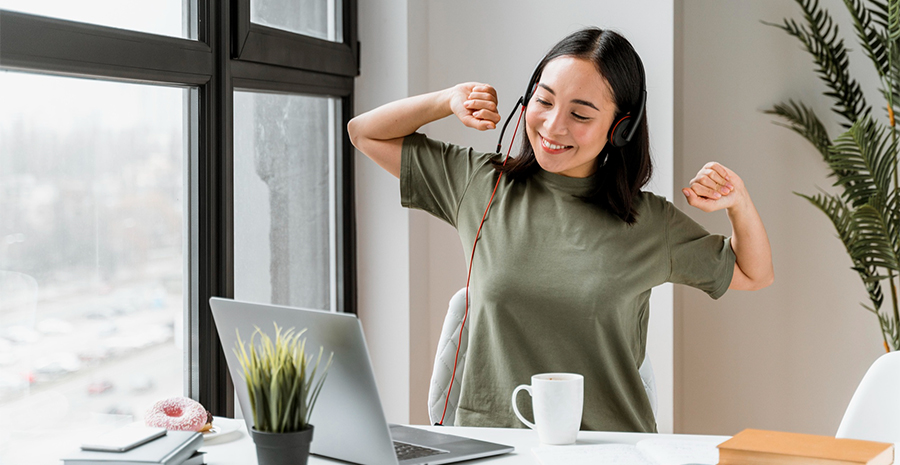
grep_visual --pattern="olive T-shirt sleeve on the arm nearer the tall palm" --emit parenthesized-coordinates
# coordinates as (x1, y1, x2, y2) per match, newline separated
(666, 202, 735, 299)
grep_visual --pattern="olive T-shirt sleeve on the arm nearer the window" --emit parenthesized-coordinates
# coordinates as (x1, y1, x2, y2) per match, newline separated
(400, 133, 493, 227)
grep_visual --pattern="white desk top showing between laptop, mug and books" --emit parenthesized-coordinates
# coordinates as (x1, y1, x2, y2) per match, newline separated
(201, 417, 729, 465)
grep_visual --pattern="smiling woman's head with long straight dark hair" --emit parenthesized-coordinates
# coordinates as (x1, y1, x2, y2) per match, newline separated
(497, 29, 653, 224)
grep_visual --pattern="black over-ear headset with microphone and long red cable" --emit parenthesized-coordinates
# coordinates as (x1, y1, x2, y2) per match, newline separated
(435, 58, 647, 426)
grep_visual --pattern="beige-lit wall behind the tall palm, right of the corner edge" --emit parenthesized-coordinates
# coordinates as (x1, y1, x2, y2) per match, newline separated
(675, 0, 884, 435)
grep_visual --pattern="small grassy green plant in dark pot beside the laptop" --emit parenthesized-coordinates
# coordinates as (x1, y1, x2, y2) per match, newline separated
(234, 324, 334, 465)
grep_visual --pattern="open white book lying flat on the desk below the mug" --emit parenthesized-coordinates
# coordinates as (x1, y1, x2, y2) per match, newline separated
(531, 438, 719, 465)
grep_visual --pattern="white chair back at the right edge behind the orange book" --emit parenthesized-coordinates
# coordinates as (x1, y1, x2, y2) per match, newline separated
(835, 351, 900, 444)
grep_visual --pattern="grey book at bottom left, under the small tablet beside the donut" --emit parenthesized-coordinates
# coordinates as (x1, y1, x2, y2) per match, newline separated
(62, 431, 203, 465)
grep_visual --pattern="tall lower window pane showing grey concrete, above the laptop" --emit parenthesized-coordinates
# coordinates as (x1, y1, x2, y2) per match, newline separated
(234, 92, 340, 310)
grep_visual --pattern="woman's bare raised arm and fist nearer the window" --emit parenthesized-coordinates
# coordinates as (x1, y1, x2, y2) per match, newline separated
(347, 82, 500, 178)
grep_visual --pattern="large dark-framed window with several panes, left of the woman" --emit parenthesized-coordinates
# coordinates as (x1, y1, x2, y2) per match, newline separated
(0, 0, 358, 464)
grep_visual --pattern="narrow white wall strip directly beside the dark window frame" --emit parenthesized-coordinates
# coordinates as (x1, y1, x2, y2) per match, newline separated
(354, 0, 411, 423)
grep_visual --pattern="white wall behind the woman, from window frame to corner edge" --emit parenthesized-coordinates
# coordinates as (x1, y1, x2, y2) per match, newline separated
(356, 0, 674, 431)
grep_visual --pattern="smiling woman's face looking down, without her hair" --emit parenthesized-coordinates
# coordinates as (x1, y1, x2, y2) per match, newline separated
(525, 56, 616, 178)
